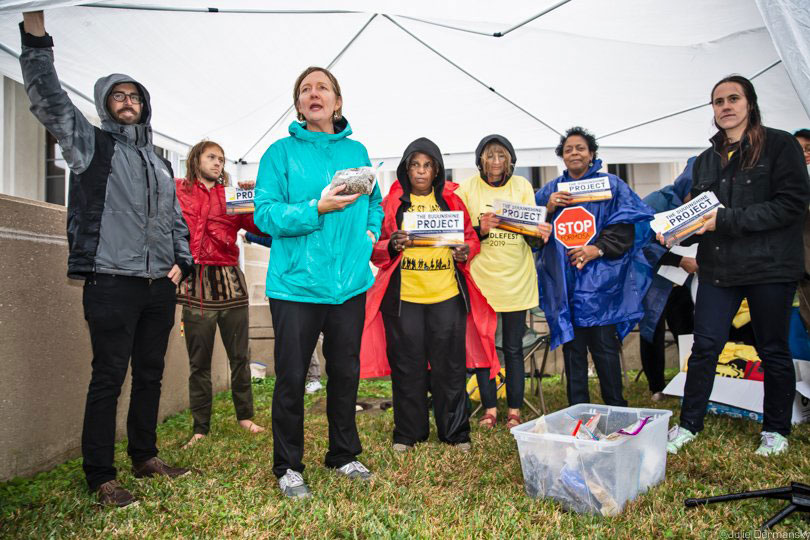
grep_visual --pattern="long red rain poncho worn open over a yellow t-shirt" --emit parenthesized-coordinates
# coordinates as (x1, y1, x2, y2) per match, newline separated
(360, 182, 501, 378)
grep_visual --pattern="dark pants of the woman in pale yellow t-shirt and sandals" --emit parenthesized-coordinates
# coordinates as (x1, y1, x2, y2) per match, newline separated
(475, 309, 526, 409)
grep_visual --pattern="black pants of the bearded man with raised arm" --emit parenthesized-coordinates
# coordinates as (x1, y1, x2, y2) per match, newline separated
(82, 274, 176, 490)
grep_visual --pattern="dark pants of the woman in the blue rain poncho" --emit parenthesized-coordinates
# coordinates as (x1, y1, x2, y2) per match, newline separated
(563, 324, 627, 407)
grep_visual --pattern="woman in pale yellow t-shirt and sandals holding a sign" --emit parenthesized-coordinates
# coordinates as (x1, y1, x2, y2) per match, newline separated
(456, 135, 551, 428)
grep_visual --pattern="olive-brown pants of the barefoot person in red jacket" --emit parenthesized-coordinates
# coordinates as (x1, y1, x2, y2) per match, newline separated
(183, 306, 253, 435)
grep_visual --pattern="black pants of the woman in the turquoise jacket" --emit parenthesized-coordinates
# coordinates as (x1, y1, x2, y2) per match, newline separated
(270, 293, 366, 478)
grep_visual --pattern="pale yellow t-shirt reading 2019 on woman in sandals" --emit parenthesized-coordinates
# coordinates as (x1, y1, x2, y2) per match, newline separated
(456, 176, 539, 312)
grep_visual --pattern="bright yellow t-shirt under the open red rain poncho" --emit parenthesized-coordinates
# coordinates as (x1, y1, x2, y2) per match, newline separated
(399, 191, 458, 304)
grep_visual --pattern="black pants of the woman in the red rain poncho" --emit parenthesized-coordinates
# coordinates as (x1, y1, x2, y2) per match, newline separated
(383, 295, 470, 445)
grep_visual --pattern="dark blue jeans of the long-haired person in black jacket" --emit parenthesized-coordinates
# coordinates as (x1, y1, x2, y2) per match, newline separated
(681, 281, 796, 436)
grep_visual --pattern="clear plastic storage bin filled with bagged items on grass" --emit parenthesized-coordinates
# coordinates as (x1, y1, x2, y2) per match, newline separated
(512, 403, 672, 516)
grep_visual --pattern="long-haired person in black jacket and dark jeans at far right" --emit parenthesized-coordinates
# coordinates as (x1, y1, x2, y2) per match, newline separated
(667, 75, 810, 455)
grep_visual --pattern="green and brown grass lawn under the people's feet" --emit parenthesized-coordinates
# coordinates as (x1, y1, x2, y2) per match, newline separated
(0, 373, 810, 539)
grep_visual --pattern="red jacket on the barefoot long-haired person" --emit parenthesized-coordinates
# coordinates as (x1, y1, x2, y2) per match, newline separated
(175, 178, 267, 266)
